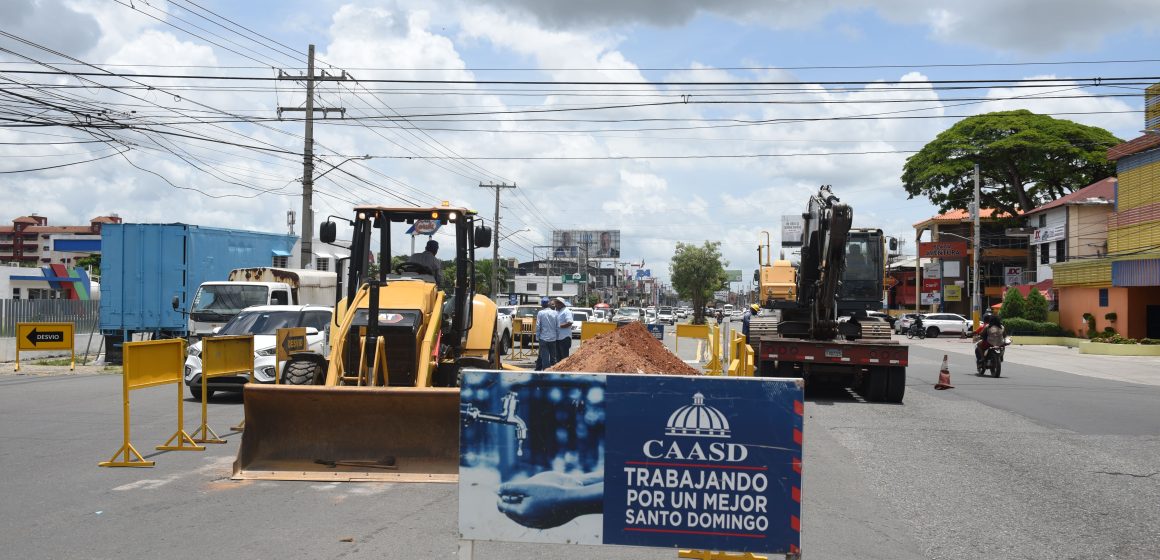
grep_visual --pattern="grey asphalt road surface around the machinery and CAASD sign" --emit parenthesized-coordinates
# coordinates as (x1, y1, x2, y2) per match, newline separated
(0, 331, 1160, 560)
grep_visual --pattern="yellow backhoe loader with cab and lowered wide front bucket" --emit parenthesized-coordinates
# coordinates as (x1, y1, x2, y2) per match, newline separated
(233, 205, 502, 482)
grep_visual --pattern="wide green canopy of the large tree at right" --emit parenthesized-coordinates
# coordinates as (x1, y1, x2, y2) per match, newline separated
(902, 110, 1121, 216)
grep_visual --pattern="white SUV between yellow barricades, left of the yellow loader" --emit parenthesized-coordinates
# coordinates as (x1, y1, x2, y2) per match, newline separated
(186, 305, 334, 399)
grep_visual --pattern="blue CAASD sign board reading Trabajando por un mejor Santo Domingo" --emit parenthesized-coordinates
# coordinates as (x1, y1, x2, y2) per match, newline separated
(459, 371, 803, 554)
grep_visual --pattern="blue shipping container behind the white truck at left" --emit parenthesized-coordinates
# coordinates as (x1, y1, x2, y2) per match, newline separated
(101, 224, 298, 363)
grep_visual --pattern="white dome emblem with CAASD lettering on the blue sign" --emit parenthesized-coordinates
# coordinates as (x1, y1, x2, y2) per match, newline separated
(641, 392, 749, 463)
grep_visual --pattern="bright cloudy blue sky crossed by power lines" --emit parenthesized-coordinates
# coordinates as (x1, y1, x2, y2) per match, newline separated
(0, 0, 1160, 282)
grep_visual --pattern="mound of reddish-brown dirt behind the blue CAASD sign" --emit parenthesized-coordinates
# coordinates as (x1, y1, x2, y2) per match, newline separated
(548, 322, 701, 376)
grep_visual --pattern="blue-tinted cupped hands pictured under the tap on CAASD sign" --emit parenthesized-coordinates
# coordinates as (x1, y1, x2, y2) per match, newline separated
(496, 472, 604, 529)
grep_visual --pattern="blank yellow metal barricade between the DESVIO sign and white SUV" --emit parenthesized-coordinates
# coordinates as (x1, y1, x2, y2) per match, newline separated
(99, 339, 197, 467)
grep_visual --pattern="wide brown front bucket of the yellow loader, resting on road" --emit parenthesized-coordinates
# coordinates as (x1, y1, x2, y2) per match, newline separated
(233, 384, 459, 482)
